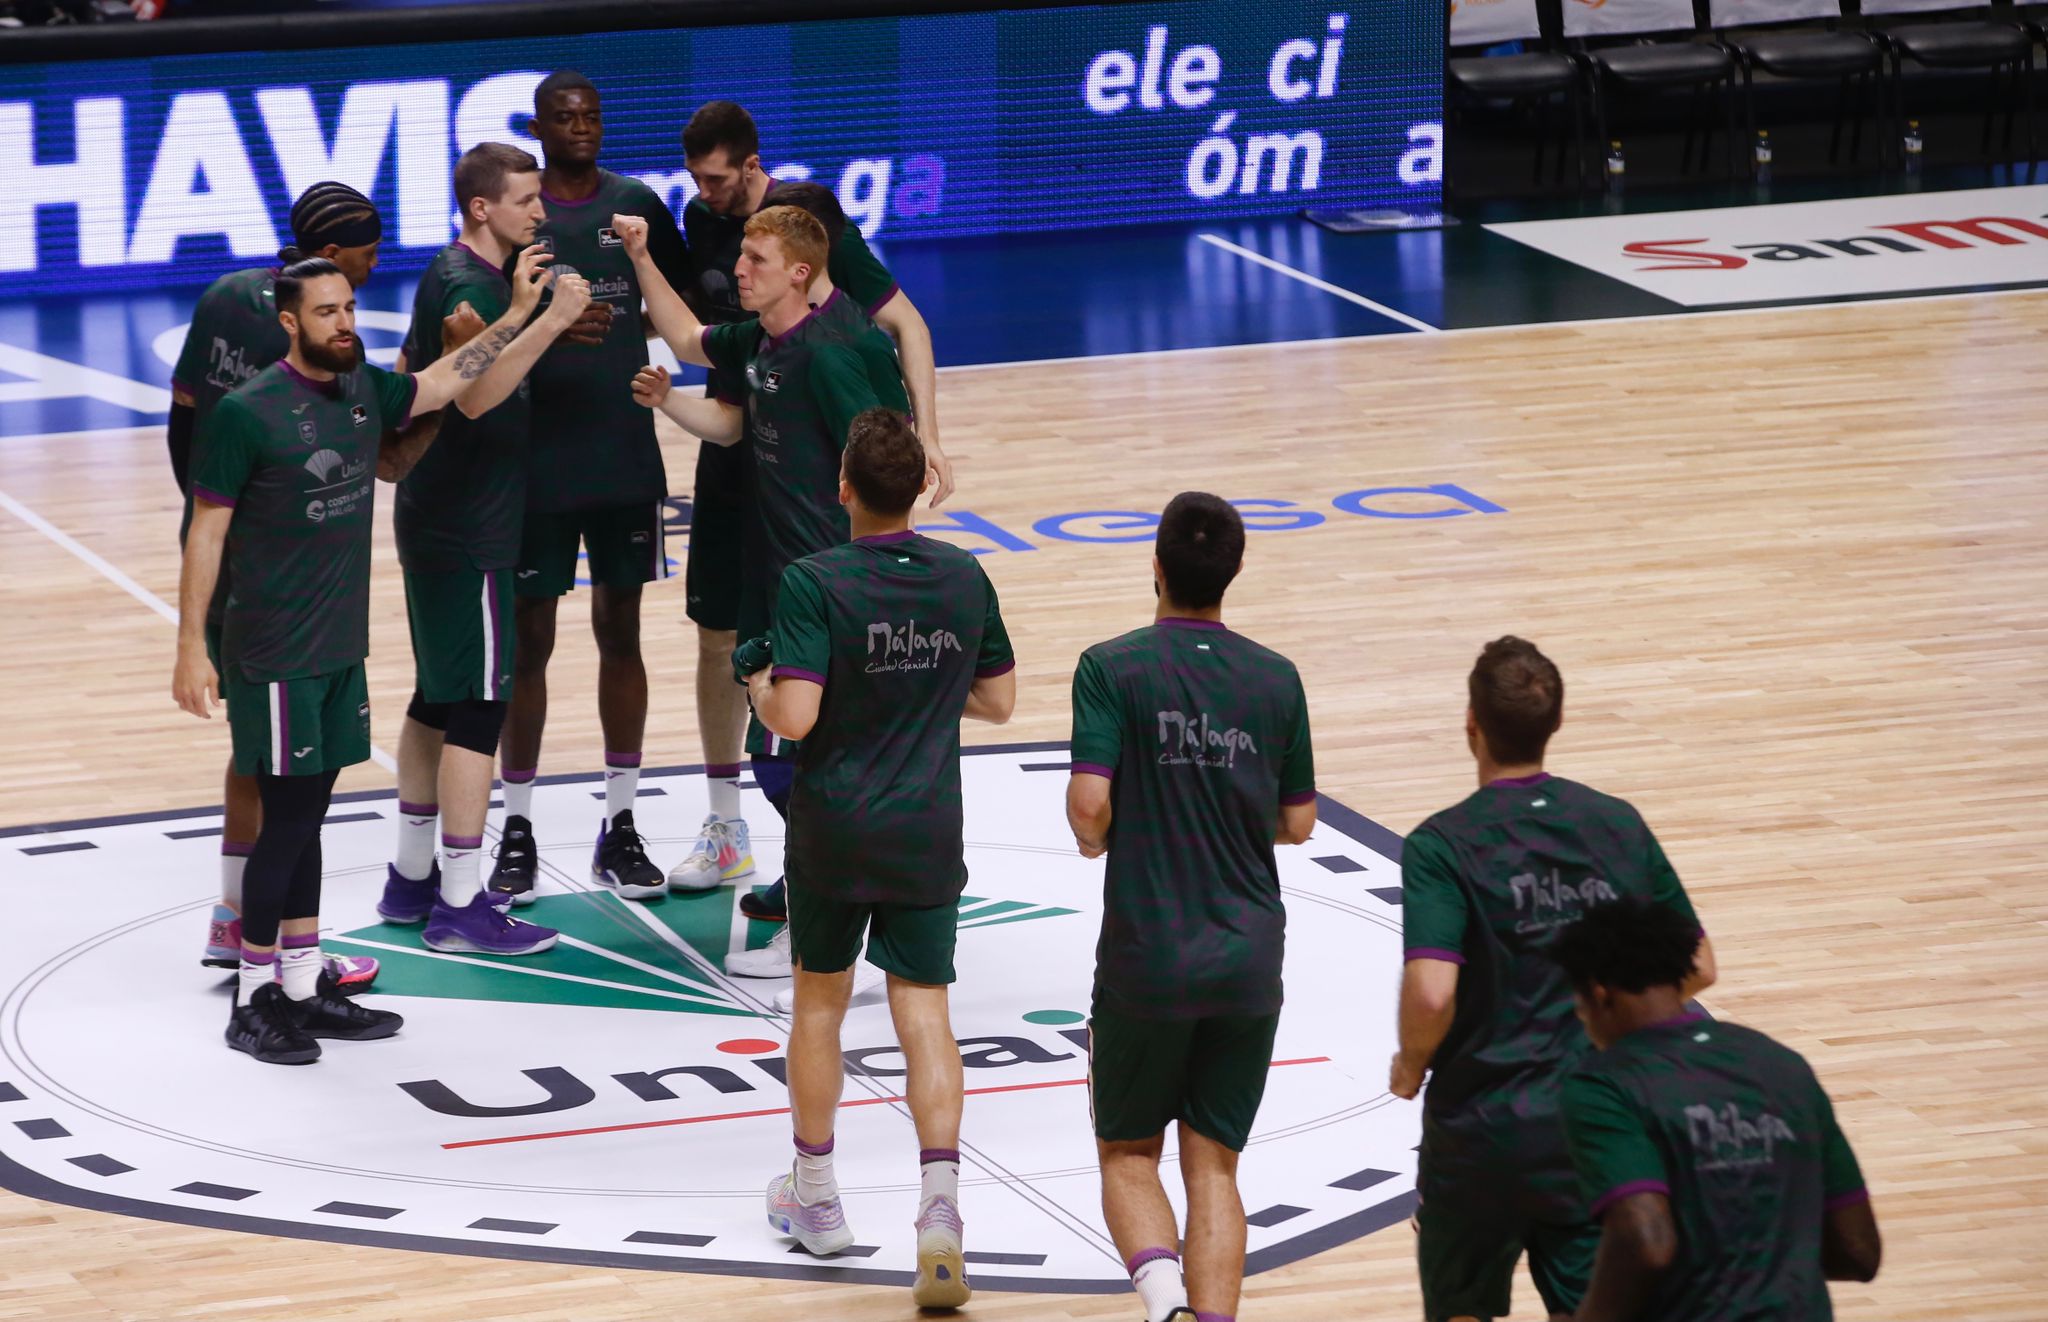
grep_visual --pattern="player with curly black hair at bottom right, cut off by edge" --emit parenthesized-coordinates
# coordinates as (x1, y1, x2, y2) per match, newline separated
(1550, 898, 1882, 1322)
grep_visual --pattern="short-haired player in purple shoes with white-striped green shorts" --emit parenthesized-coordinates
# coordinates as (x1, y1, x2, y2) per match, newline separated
(377, 143, 557, 956)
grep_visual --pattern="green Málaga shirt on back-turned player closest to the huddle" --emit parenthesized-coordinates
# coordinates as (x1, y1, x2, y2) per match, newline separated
(770, 532, 1016, 909)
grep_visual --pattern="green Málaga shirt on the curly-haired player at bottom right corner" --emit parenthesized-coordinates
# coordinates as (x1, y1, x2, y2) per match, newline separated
(1565, 1015, 1868, 1322)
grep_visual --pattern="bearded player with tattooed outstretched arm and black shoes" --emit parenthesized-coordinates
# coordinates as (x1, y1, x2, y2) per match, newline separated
(172, 248, 590, 1064)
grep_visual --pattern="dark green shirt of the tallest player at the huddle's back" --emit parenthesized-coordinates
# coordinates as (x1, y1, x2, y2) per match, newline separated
(526, 170, 688, 512)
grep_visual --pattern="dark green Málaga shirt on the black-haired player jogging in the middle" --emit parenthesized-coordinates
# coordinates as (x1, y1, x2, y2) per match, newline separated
(1073, 618, 1315, 1019)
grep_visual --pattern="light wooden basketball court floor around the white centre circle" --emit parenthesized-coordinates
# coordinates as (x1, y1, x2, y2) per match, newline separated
(0, 274, 2048, 1322)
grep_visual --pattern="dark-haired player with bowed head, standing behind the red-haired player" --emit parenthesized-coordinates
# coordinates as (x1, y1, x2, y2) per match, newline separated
(670, 100, 952, 919)
